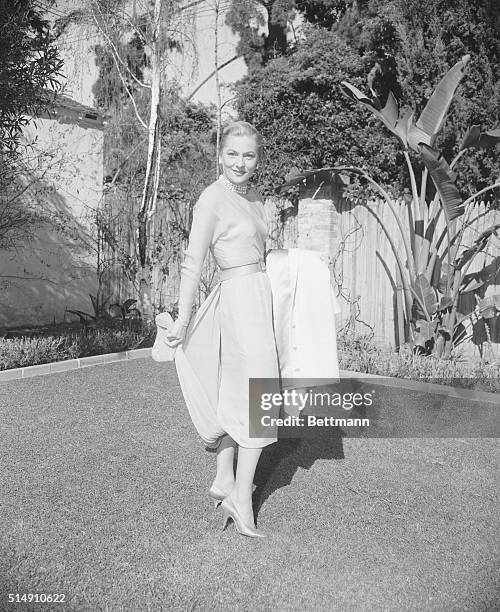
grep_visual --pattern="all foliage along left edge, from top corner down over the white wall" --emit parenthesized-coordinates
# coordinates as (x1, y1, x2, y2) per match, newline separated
(0, 0, 66, 249)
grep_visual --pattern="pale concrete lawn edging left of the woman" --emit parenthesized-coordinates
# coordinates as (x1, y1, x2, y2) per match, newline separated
(0, 348, 151, 382)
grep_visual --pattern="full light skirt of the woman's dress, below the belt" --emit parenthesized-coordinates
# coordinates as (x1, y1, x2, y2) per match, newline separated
(175, 271, 279, 448)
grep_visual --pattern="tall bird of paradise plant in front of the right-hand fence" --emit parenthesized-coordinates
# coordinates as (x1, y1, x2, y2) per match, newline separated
(278, 55, 500, 358)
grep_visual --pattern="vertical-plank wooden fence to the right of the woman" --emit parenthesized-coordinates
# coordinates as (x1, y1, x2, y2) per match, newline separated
(266, 193, 500, 355)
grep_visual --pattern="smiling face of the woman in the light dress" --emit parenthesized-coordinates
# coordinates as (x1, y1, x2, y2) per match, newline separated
(219, 136, 259, 185)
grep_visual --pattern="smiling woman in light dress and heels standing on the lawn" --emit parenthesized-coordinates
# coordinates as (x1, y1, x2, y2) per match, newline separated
(168, 121, 279, 537)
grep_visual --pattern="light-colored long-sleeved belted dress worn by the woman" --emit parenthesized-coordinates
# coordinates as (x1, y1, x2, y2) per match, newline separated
(175, 179, 279, 448)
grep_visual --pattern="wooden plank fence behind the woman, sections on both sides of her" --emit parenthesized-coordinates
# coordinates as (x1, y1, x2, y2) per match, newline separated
(102, 190, 500, 354)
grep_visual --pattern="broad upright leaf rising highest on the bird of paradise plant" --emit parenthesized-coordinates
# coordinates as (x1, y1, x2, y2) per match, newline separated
(415, 55, 470, 145)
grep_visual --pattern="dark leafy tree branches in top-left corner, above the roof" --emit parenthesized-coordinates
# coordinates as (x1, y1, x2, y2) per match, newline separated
(0, 0, 63, 152)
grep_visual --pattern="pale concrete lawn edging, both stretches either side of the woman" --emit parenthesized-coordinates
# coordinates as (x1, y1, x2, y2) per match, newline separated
(0, 348, 499, 406)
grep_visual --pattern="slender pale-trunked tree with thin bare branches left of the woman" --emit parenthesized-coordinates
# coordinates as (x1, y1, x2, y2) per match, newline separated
(83, 0, 196, 316)
